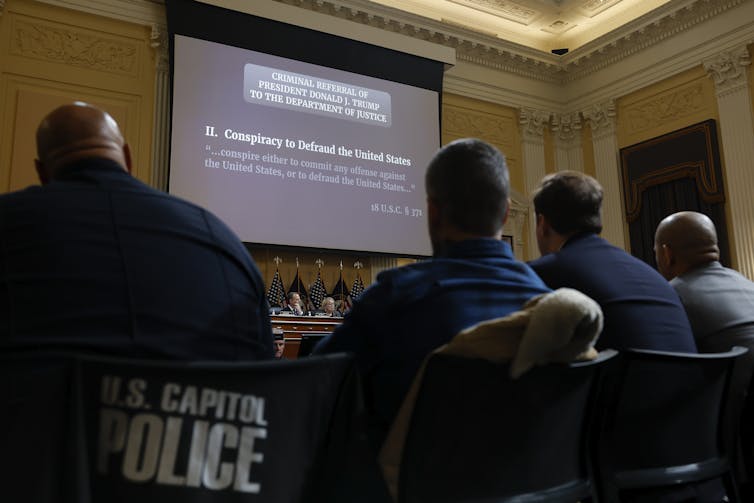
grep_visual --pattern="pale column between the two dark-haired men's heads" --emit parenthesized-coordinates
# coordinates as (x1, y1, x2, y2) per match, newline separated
(518, 108, 550, 260)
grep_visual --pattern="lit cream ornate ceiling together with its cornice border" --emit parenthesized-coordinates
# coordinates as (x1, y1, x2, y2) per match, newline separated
(274, 0, 754, 84)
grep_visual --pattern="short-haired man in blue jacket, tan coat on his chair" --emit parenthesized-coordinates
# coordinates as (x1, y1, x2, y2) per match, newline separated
(315, 139, 549, 447)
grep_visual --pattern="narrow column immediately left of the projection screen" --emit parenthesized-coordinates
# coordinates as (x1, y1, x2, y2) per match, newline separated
(150, 24, 170, 190)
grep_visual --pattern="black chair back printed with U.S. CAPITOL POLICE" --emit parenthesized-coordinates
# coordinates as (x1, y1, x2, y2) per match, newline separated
(0, 354, 376, 503)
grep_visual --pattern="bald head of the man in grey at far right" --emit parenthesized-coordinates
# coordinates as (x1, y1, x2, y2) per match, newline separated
(655, 211, 720, 279)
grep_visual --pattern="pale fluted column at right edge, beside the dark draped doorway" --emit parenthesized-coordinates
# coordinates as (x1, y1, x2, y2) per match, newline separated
(704, 46, 754, 279)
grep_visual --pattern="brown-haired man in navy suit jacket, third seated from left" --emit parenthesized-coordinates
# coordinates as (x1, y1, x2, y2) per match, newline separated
(529, 171, 696, 353)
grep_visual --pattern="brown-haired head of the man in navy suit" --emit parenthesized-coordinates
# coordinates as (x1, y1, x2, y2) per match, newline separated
(534, 171, 602, 235)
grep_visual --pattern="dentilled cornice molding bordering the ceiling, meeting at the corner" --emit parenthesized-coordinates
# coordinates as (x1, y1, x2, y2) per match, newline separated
(273, 0, 753, 84)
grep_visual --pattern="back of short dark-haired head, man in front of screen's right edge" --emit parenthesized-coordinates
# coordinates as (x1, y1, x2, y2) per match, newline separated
(426, 138, 510, 236)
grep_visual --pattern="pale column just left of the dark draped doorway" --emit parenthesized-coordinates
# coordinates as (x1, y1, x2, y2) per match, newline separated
(584, 100, 626, 249)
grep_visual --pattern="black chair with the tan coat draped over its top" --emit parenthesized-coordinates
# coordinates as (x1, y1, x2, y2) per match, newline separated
(399, 351, 615, 503)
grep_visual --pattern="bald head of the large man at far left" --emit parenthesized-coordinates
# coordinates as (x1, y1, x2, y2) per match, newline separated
(35, 103, 131, 184)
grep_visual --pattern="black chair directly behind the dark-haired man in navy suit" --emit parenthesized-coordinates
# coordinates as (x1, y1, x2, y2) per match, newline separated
(594, 347, 746, 502)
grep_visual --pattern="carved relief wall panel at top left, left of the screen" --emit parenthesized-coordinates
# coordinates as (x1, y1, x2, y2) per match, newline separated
(10, 19, 138, 76)
